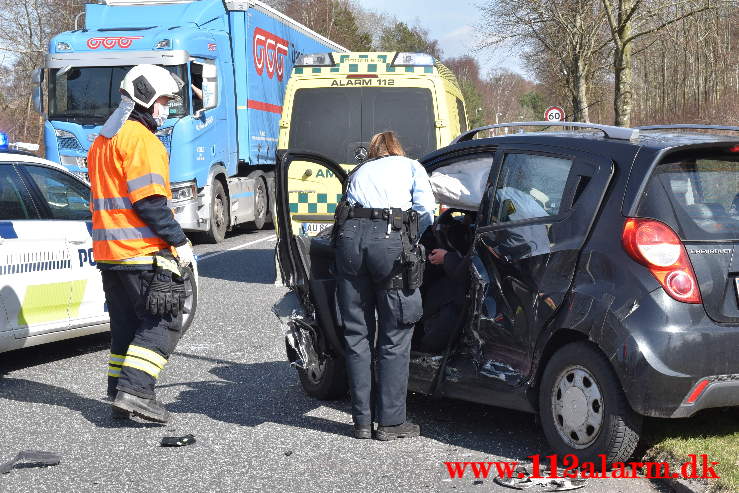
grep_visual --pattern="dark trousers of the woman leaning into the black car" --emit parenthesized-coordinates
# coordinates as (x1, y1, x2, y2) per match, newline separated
(336, 219, 422, 426)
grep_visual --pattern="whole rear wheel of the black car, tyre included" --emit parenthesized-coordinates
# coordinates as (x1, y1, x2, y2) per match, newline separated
(539, 342, 642, 464)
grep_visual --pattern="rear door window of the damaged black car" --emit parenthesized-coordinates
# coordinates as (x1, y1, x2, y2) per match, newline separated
(492, 153, 573, 222)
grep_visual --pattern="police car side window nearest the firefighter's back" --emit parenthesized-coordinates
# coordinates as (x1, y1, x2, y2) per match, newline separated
(26, 166, 92, 220)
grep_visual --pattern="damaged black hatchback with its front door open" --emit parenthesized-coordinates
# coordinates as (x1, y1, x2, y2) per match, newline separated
(275, 123, 739, 462)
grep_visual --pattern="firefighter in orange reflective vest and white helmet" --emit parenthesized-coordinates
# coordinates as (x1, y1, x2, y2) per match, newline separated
(88, 65, 194, 423)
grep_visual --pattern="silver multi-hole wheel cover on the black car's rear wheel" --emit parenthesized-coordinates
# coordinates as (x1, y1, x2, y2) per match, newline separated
(552, 365, 603, 449)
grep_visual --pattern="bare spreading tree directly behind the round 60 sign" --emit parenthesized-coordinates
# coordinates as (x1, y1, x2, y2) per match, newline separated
(480, 0, 609, 121)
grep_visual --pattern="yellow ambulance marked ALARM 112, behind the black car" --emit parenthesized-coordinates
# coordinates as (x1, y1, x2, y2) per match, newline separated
(278, 52, 467, 236)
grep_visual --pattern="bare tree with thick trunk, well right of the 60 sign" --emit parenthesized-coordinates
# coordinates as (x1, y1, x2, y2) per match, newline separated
(601, 0, 711, 127)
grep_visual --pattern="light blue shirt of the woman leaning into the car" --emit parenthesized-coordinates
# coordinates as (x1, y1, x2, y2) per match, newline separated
(346, 156, 436, 232)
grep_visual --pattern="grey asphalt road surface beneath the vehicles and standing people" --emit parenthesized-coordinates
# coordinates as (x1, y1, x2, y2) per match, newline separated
(0, 231, 665, 493)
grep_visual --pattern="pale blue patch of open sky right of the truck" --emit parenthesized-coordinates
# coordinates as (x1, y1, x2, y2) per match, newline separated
(356, 0, 523, 75)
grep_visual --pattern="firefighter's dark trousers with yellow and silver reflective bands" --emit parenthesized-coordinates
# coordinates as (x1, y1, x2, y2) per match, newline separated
(102, 270, 182, 398)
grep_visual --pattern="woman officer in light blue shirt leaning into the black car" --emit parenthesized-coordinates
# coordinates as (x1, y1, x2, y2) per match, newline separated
(335, 132, 435, 440)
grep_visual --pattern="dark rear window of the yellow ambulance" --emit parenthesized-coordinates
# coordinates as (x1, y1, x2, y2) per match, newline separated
(289, 87, 436, 164)
